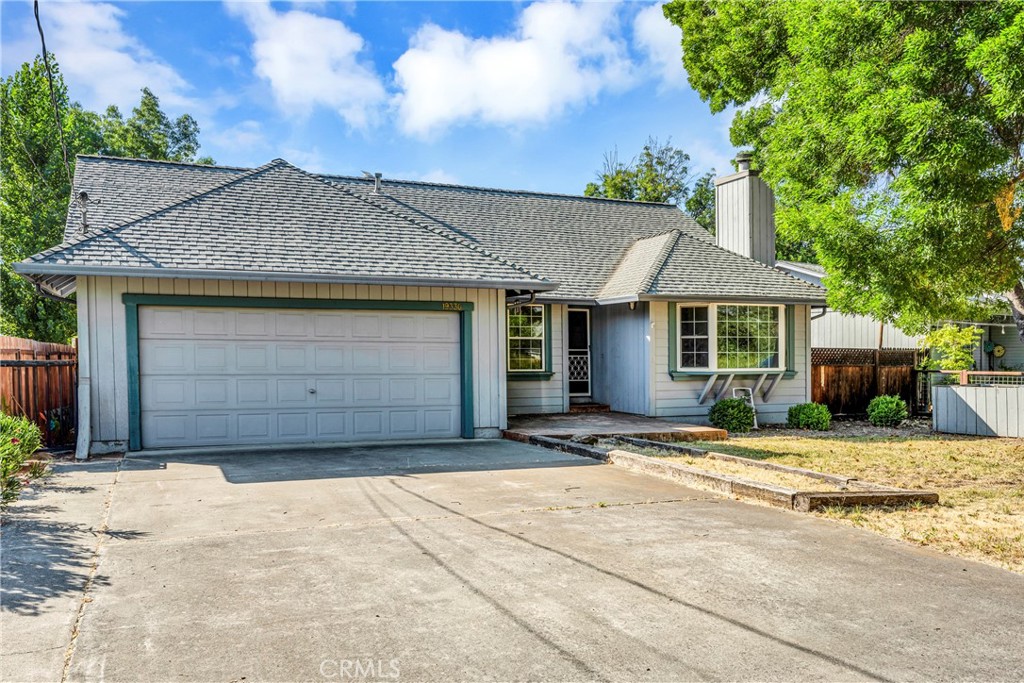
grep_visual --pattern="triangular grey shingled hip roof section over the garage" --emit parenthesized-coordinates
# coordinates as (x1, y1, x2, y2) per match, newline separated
(25, 160, 553, 290)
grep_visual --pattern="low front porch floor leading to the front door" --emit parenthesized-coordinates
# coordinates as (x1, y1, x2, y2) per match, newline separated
(503, 413, 728, 441)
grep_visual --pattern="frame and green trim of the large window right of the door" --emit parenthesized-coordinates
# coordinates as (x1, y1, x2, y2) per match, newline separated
(669, 302, 796, 379)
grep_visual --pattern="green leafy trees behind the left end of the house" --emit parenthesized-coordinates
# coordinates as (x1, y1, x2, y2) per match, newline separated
(0, 55, 213, 342)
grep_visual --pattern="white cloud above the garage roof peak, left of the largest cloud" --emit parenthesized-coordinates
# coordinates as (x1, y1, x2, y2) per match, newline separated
(227, 2, 385, 128)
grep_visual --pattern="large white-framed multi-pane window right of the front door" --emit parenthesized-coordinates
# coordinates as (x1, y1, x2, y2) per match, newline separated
(677, 304, 782, 371)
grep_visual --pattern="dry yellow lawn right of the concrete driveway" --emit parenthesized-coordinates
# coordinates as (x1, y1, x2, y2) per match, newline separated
(693, 430, 1024, 572)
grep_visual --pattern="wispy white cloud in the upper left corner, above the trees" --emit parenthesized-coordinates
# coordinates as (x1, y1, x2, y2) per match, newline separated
(24, 2, 195, 114)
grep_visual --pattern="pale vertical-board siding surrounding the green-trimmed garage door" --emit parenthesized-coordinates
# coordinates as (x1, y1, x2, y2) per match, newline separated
(78, 278, 508, 453)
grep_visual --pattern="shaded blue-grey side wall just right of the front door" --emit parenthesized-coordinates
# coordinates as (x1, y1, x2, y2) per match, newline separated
(591, 302, 650, 415)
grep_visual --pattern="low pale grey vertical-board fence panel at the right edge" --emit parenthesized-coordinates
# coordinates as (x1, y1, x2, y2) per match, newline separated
(932, 385, 1024, 438)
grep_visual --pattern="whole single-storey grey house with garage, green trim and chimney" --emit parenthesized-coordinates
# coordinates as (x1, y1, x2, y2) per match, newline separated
(14, 156, 824, 456)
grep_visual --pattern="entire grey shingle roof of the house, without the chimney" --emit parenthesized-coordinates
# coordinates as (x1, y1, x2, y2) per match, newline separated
(17, 157, 824, 303)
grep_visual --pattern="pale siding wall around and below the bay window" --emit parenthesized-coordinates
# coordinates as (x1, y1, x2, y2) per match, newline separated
(648, 301, 811, 424)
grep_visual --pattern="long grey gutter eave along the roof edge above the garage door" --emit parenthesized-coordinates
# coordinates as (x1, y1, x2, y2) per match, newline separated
(12, 261, 558, 296)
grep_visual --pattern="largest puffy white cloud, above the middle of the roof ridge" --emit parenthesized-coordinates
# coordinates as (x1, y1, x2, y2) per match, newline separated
(394, 1, 633, 137)
